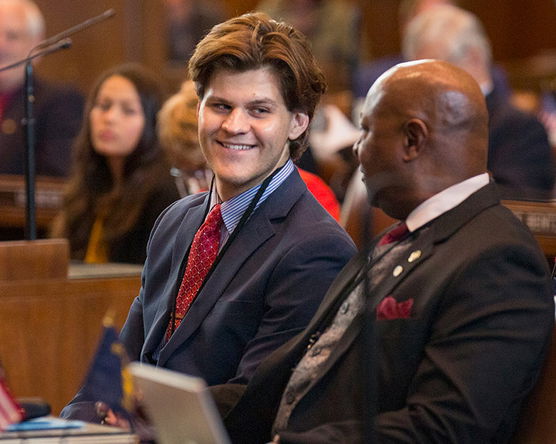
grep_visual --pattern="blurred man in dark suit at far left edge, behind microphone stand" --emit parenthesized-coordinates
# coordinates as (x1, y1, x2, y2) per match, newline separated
(0, 0, 83, 176)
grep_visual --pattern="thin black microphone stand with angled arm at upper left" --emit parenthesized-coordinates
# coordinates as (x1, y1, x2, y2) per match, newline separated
(0, 9, 115, 240)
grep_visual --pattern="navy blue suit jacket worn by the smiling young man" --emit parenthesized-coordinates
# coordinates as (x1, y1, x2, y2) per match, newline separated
(121, 171, 355, 385)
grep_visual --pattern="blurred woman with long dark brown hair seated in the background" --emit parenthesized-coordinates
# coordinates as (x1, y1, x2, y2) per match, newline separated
(52, 64, 179, 264)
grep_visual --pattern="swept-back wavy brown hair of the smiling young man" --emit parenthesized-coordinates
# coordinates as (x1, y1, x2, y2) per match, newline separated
(189, 12, 326, 160)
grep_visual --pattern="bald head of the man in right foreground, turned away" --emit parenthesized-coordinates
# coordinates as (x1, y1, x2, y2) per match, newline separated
(356, 60, 488, 218)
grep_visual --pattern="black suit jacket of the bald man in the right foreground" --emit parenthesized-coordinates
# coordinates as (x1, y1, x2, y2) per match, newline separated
(213, 185, 554, 443)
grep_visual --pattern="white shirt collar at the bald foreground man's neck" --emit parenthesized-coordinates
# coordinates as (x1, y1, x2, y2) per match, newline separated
(405, 173, 489, 231)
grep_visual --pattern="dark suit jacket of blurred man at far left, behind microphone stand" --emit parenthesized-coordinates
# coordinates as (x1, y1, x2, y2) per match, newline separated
(0, 78, 83, 176)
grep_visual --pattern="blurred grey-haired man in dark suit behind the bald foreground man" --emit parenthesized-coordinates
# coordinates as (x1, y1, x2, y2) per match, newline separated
(403, 5, 554, 199)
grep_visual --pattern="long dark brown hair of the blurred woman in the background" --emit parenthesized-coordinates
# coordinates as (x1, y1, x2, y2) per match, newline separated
(51, 64, 168, 259)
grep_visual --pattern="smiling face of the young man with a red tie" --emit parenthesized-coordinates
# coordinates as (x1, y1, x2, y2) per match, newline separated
(199, 68, 309, 200)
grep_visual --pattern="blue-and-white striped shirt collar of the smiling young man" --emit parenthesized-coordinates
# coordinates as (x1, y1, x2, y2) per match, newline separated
(210, 159, 295, 233)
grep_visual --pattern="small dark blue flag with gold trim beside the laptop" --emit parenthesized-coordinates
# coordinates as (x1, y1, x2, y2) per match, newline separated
(83, 316, 133, 415)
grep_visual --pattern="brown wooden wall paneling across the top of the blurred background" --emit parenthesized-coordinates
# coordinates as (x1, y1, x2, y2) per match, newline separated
(28, 0, 556, 96)
